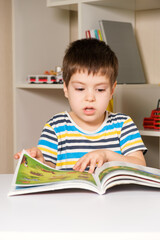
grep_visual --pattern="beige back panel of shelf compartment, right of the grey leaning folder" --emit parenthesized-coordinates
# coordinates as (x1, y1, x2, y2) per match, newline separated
(136, 9, 160, 84)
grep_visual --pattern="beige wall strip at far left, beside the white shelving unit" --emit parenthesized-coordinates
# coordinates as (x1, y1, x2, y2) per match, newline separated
(0, 0, 13, 173)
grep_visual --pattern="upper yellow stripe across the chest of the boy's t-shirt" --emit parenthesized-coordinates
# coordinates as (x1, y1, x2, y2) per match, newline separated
(58, 131, 120, 139)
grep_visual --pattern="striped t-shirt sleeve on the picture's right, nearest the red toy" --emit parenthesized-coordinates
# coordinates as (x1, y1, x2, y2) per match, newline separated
(120, 117, 147, 155)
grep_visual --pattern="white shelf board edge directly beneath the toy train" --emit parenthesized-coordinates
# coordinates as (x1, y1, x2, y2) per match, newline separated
(16, 84, 63, 89)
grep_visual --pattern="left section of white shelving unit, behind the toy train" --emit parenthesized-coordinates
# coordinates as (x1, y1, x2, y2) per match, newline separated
(12, 0, 70, 161)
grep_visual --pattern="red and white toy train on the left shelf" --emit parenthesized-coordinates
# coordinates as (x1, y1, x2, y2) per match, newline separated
(27, 67, 63, 84)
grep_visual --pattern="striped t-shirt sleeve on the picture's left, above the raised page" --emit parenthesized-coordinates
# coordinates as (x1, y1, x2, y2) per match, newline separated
(38, 123, 58, 164)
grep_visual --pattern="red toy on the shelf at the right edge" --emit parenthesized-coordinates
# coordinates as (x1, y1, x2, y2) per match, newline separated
(143, 99, 160, 130)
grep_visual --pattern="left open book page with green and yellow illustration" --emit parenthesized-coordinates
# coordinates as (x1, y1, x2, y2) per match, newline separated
(12, 152, 97, 187)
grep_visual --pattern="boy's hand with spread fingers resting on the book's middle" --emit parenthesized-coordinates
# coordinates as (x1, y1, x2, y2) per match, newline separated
(73, 149, 107, 173)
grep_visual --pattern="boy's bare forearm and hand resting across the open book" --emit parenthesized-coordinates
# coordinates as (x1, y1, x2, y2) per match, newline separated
(73, 149, 146, 173)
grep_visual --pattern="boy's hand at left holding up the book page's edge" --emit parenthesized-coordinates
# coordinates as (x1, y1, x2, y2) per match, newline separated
(14, 147, 45, 163)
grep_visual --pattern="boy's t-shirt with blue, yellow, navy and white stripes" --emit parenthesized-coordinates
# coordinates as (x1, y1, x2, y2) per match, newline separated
(38, 112, 146, 169)
